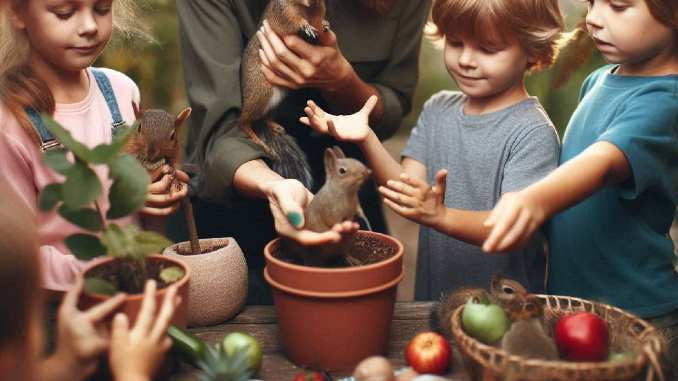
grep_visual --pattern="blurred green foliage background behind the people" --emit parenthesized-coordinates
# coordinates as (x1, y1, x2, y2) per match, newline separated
(97, 0, 604, 134)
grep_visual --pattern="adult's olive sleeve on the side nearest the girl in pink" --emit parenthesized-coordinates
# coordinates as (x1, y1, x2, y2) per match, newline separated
(176, 0, 265, 203)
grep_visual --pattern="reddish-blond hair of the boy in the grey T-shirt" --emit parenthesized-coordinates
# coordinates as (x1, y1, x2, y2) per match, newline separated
(426, 0, 565, 70)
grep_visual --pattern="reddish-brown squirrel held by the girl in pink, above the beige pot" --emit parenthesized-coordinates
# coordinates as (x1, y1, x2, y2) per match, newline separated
(123, 102, 200, 254)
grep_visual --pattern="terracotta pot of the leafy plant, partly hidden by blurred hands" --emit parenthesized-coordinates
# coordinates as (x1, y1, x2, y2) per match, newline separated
(79, 255, 191, 327)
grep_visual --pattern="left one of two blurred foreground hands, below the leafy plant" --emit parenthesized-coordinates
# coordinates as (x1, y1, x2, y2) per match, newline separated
(49, 277, 125, 380)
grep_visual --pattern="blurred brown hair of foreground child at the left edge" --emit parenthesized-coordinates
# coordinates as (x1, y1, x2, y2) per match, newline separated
(0, 186, 42, 348)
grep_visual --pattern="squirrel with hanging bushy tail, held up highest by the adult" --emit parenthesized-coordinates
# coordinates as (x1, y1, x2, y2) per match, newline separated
(238, 0, 329, 189)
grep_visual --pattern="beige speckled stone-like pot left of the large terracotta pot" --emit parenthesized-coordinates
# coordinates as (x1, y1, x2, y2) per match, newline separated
(163, 237, 247, 326)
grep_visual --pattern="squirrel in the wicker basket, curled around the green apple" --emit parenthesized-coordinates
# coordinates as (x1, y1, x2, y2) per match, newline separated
(431, 274, 558, 360)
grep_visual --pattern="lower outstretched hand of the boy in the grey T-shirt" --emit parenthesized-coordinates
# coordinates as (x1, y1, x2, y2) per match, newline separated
(379, 169, 447, 226)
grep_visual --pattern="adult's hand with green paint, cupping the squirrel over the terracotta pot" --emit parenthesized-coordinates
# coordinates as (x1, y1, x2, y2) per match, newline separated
(264, 179, 359, 246)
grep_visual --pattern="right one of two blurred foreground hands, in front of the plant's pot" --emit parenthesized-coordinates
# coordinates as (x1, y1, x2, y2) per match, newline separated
(109, 280, 181, 381)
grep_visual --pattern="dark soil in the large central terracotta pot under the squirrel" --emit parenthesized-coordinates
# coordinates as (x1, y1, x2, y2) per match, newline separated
(273, 234, 397, 268)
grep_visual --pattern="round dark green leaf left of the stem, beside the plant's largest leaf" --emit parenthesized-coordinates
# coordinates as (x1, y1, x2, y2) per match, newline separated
(61, 161, 101, 209)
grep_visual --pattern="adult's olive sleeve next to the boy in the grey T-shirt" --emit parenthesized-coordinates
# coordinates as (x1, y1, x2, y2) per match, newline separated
(371, 0, 431, 140)
